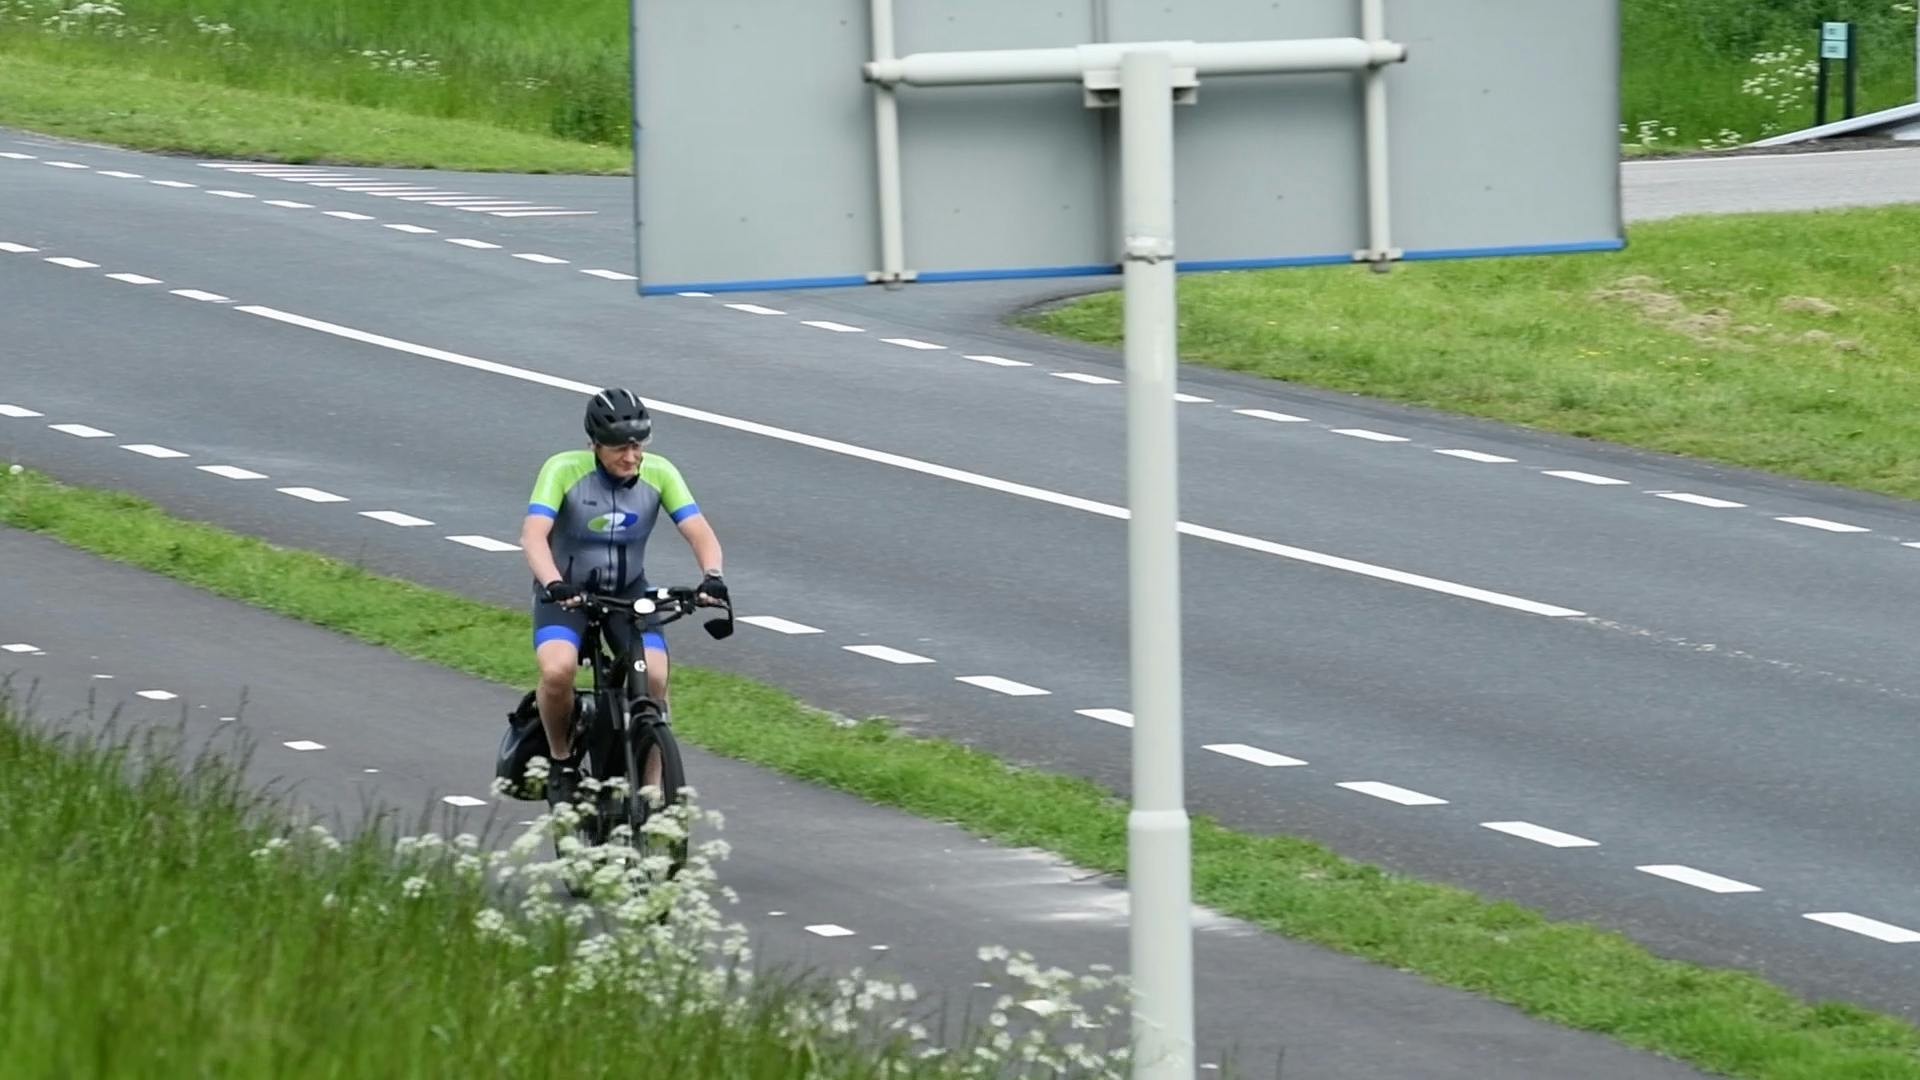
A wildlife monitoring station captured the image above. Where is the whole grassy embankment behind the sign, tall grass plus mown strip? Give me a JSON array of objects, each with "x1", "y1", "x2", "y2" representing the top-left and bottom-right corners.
[{"x1": 0, "y1": 0, "x2": 1914, "y2": 171}]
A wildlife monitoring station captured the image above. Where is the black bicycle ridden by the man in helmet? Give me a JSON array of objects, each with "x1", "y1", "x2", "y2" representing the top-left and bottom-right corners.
[{"x1": 553, "y1": 586, "x2": 733, "y2": 880}]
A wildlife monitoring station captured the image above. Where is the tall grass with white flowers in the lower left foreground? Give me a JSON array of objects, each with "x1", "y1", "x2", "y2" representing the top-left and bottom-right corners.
[{"x1": 0, "y1": 701, "x2": 1075, "y2": 1080}]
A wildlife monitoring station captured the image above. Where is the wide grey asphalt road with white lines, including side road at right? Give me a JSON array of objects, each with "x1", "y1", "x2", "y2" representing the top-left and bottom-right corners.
[{"x1": 0, "y1": 127, "x2": 1920, "y2": 1017}]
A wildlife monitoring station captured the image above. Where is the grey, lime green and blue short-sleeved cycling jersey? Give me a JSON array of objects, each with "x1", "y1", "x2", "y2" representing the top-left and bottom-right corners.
[{"x1": 526, "y1": 450, "x2": 701, "y2": 592}]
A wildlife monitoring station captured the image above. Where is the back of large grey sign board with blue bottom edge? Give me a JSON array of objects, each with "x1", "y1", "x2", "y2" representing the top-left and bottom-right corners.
[{"x1": 634, "y1": 0, "x2": 1622, "y2": 292}]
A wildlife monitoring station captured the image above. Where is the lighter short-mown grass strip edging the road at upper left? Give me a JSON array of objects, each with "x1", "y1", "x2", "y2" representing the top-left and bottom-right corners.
[{"x1": 0, "y1": 52, "x2": 632, "y2": 173}]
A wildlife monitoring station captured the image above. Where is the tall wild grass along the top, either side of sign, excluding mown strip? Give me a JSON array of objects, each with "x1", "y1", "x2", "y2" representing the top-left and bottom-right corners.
[{"x1": 0, "y1": 0, "x2": 1914, "y2": 146}]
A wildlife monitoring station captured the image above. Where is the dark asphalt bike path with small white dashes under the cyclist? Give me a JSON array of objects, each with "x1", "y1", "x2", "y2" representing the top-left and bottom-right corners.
[{"x1": 0, "y1": 528, "x2": 1699, "y2": 1080}]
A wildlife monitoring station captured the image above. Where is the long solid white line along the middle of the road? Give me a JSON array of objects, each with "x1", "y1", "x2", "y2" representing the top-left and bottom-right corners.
[{"x1": 236, "y1": 304, "x2": 1584, "y2": 619}]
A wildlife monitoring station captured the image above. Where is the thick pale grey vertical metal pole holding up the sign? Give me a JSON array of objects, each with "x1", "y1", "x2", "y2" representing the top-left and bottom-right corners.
[{"x1": 1119, "y1": 52, "x2": 1194, "y2": 1080}]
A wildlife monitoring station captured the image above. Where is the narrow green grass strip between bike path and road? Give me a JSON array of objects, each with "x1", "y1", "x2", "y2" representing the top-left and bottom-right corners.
[{"x1": 0, "y1": 471, "x2": 1920, "y2": 1080}]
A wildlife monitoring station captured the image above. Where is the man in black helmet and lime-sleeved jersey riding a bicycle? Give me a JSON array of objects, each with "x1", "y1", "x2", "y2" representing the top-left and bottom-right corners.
[{"x1": 520, "y1": 386, "x2": 728, "y2": 803}]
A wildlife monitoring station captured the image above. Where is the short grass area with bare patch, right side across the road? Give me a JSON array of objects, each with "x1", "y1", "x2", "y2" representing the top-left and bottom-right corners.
[{"x1": 1020, "y1": 206, "x2": 1920, "y2": 498}]
